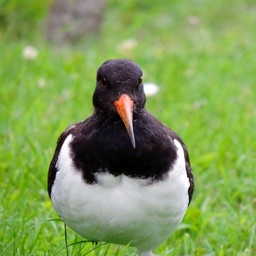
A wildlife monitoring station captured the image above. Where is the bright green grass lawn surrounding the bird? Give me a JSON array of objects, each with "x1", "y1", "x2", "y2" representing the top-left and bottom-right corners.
[{"x1": 0, "y1": 0, "x2": 256, "y2": 256}]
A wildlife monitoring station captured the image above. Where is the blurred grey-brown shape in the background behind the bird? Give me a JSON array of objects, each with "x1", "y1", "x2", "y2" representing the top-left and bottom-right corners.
[{"x1": 46, "y1": 0, "x2": 106, "y2": 44}]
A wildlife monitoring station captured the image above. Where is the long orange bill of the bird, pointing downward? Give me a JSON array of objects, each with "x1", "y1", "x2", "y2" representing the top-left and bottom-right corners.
[{"x1": 114, "y1": 94, "x2": 136, "y2": 148}]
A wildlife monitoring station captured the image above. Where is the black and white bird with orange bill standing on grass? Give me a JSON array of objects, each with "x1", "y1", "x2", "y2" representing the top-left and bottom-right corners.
[{"x1": 48, "y1": 59, "x2": 194, "y2": 256}]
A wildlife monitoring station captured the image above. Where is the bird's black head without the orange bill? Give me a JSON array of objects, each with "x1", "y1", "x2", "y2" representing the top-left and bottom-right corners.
[{"x1": 93, "y1": 59, "x2": 146, "y2": 112}]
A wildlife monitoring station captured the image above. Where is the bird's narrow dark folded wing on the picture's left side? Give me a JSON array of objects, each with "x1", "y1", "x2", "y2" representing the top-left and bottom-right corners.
[{"x1": 48, "y1": 122, "x2": 82, "y2": 197}]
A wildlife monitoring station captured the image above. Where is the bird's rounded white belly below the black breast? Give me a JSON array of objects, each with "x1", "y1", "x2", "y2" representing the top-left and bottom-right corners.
[{"x1": 51, "y1": 135, "x2": 189, "y2": 251}]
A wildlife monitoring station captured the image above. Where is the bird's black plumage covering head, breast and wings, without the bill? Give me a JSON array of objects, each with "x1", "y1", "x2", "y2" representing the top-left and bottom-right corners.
[{"x1": 48, "y1": 59, "x2": 194, "y2": 200}]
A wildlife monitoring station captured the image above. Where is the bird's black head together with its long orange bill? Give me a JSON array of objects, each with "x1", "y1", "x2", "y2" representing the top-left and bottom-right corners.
[{"x1": 93, "y1": 59, "x2": 146, "y2": 148}]
